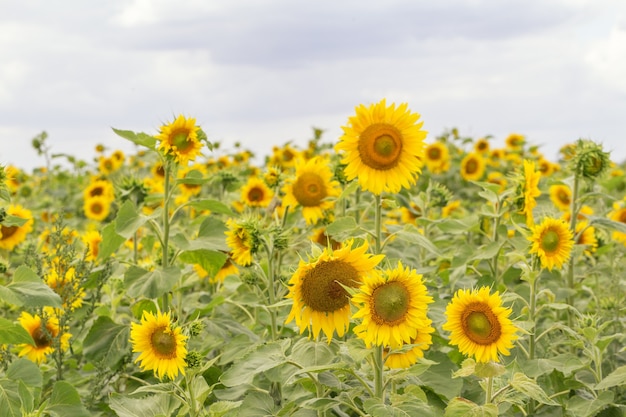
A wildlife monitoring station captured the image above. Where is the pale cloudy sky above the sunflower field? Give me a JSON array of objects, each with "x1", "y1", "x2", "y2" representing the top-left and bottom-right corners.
[{"x1": 0, "y1": 0, "x2": 626, "y2": 170}]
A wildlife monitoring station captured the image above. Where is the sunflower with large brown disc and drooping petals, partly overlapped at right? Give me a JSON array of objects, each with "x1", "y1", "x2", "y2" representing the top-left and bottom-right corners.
[{"x1": 285, "y1": 240, "x2": 384, "y2": 343}]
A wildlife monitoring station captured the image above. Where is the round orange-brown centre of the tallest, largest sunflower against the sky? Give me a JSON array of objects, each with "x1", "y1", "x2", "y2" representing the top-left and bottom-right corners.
[{"x1": 358, "y1": 123, "x2": 402, "y2": 171}]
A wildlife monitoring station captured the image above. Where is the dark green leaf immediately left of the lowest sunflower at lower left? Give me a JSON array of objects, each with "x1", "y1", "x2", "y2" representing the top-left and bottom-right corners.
[{"x1": 83, "y1": 316, "x2": 130, "y2": 369}]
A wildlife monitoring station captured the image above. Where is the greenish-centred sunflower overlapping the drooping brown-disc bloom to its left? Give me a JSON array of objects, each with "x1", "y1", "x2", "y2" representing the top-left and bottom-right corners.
[{"x1": 352, "y1": 262, "x2": 434, "y2": 350}]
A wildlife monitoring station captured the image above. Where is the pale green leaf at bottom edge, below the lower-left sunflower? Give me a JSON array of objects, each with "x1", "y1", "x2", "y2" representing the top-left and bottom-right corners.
[{"x1": 109, "y1": 393, "x2": 180, "y2": 417}]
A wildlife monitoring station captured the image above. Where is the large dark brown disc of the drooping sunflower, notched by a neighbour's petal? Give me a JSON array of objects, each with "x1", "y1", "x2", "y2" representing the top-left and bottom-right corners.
[{"x1": 302, "y1": 260, "x2": 360, "y2": 313}]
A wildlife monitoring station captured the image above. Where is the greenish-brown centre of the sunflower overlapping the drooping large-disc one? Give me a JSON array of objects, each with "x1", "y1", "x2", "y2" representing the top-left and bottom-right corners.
[{"x1": 372, "y1": 281, "x2": 410, "y2": 325}]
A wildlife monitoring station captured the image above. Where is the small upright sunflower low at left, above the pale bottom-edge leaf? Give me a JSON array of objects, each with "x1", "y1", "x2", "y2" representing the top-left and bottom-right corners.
[{"x1": 130, "y1": 310, "x2": 187, "y2": 379}]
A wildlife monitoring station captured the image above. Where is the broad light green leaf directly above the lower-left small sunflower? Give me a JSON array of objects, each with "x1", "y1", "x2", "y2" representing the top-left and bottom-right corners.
[{"x1": 124, "y1": 266, "x2": 180, "y2": 298}]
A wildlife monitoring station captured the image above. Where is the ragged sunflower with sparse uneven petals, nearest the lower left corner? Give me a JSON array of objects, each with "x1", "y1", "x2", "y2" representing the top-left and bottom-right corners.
[{"x1": 18, "y1": 311, "x2": 72, "y2": 363}]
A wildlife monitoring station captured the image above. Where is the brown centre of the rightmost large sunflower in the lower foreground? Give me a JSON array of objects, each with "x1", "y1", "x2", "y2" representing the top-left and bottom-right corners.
[{"x1": 461, "y1": 303, "x2": 502, "y2": 345}]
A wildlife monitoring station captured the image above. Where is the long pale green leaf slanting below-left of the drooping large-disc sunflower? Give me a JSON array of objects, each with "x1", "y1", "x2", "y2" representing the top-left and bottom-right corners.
[{"x1": 220, "y1": 342, "x2": 287, "y2": 387}]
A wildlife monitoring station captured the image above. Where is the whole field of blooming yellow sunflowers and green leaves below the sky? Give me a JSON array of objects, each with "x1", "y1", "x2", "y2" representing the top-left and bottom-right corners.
[{"x1": 0, "y1": 100, "x2": 626, "y2": 417}]
